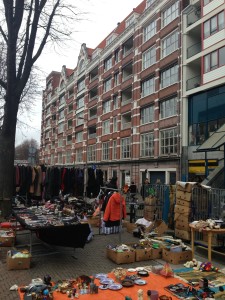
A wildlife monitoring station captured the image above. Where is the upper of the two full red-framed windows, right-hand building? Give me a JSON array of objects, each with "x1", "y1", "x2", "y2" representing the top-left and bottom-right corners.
[{"x1": 204, "y1": 11, "x2": 225, "y2": 39}]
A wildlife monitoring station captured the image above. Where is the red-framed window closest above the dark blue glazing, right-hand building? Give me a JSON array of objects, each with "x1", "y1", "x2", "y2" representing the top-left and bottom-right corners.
[{"x1": 204, "y1": 47, "x2": 225, "y2": 73}]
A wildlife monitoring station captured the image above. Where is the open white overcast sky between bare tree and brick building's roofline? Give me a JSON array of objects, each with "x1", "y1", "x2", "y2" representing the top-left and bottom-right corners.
[{"x1": 16, "y1": 0, "x2": 142, "y2": 145}]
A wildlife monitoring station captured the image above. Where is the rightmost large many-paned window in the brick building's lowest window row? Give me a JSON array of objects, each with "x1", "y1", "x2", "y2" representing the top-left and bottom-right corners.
[{"x1": 160, "y1": 128, "x2": 178, "y2": 155}]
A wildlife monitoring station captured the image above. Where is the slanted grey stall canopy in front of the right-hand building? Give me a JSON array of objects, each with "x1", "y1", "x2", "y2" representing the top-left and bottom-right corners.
[{"x1": 195, "y1": 124, "x2": 225, "y2": 186}]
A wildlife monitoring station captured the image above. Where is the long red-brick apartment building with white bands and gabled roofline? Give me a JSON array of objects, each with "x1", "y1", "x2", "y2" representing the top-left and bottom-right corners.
[{"x1": 40, "y1": 0, "x2": 189, "y2": 187}]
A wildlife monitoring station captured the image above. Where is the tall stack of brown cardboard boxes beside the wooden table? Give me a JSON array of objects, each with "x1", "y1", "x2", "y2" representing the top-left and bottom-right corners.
[{"x1": 174, "y1": 181, "x2": 195, "y2": 241}]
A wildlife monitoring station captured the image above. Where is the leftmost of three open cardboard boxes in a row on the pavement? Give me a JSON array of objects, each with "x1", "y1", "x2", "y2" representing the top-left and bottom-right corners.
[{"x1": 106, "y1": 249, "x2": 135, "y2": 265}]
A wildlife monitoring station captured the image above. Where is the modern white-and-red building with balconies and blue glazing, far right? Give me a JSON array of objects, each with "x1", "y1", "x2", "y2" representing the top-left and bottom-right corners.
[{"x1": 181, "y1": 0, "x2": 225, "y2": 180}]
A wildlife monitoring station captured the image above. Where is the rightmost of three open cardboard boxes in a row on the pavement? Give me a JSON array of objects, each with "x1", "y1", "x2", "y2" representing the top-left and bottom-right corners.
[{"x1": 162, "y1": 248, "x2": 192, "y2": 265}]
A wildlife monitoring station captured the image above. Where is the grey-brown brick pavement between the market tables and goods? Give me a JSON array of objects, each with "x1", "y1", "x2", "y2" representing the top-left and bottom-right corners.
[{"x1": 0, "y1": 228, "x2": 225, "y2": 300}]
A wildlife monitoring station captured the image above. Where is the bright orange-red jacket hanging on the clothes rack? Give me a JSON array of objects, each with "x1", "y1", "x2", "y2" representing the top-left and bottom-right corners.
[{"x1": 103, "y1": 193, "x2": 127, "y2": 222}]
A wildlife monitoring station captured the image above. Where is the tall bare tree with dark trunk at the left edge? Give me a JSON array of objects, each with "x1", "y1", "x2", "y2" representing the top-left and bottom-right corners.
[{"x1": 0, "y1": 0, "x2": 83, "y2": 216}]
